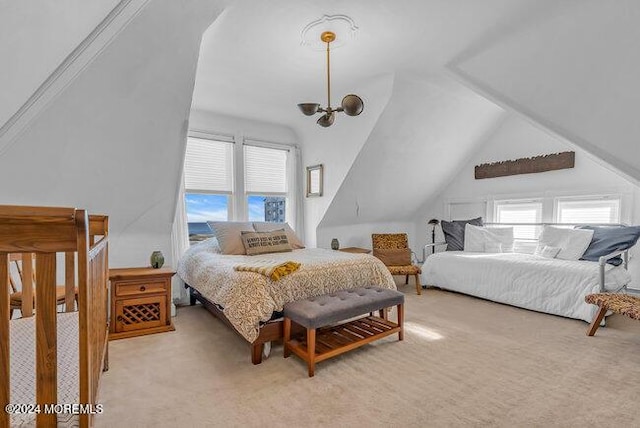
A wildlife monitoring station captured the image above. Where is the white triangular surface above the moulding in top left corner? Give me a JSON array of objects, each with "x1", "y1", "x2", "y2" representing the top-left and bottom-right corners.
[{"x1": 0, "y1": 0, "x2": 118, "y2": 126}]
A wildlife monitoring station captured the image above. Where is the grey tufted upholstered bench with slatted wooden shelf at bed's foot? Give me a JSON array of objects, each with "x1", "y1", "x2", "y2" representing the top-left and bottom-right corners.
[{"x1": 284, "y1": 287, "x2": 404, "y2": 377}]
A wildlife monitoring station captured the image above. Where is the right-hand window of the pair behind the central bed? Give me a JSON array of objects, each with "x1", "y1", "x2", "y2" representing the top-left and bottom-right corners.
[{"x1": 244, "y1": 145, "x2": 289, "y2": 222}]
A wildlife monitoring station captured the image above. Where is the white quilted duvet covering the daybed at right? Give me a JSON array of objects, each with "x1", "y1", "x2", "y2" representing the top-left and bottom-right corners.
[{"x1": 422, "y1": 251, "x2": 631, "y2": 322}]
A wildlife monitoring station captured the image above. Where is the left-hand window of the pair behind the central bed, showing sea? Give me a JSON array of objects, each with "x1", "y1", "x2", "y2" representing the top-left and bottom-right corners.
[{"x1": 184, "y1": 137, "x2": 233, "y2": 242}]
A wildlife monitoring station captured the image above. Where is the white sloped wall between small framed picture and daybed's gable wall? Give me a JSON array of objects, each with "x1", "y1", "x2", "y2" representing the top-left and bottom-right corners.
[{"x1": 318, "y1": 75, "x2": 502, "y2": 251}]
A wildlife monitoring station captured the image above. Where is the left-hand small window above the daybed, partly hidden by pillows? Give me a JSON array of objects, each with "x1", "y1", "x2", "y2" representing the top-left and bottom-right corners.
[{"x1": 493, "y1": 200, "x2": 542, "y2": 241}]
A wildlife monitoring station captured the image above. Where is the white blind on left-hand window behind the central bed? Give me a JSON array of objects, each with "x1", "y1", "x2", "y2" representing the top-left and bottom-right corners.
[{"x1": 184, "y1": 137, "x2": 233, "y2": 193}]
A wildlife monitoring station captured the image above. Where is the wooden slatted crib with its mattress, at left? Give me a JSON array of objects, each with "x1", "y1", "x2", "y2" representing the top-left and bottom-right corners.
[{"x1": 0, "y1": 206, "x2": 108, "y2": 428}]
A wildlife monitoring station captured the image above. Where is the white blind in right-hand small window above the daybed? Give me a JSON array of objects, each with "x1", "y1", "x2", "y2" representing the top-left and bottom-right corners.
[{"x1": 557, "y1": 198, "x2": 620, "y2": 224}]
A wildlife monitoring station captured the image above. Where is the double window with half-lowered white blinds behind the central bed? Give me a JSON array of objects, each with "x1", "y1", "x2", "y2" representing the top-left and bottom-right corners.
[{"x1": 184, "y1": 132, "x2": 295, "y2": 243}]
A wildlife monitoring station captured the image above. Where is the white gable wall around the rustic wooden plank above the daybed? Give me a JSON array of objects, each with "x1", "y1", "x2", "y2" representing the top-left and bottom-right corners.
[{"x1": 415, "y1": 115, "x2": 640, "y2": 288}]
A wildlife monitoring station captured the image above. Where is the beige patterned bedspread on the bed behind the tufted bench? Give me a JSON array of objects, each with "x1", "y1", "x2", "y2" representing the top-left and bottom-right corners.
[{"x1": 178, "y1": 241, "x2": 396, "y2": 342}]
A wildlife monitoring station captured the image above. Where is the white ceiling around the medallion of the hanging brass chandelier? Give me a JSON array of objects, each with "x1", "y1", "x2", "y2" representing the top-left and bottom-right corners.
[{"x1": 192, "y1": 0, "x2": 557, "y2": 129}]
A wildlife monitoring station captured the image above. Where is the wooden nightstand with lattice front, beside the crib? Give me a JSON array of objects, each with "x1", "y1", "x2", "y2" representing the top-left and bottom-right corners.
[{"x1": 109, "y1": 268, "x2": 175, "y2": 340}]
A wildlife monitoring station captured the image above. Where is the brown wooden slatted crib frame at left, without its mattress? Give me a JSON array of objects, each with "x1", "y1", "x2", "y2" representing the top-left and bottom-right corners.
[{"x1": 0, "y1": 206, "x2": 109, "y2": 428}]
